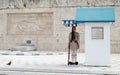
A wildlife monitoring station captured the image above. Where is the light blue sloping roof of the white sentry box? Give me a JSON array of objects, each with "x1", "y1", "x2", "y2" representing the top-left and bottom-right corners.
[{"x1": 75, "y1": 8, "x2": 115, "y2": 22}]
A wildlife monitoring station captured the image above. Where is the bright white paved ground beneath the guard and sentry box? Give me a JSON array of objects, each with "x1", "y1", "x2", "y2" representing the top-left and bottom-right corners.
[{"x1": 0, "y1": 52, "x2": 120, "y2": 75}]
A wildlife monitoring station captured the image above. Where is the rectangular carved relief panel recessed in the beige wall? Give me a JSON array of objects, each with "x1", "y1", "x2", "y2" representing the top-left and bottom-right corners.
[{"x1": 7, "y1": 12, "x2": 53, "y2": 35}]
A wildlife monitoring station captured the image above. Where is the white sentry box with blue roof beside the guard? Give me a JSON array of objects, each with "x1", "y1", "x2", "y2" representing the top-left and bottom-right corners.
[{"x1": 63, "y1": 8, "x2": 115, "y2": 66}]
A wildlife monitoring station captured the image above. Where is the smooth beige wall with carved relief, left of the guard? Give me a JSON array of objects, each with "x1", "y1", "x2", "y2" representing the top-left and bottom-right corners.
[{"x1": 0, "y1": 8, "x2": 78, "y2": 51}]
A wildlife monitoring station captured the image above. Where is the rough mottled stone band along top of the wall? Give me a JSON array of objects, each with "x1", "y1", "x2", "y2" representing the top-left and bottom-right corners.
[{"x1": 0, "y1": 0, "x2": 120, "y2": 9}]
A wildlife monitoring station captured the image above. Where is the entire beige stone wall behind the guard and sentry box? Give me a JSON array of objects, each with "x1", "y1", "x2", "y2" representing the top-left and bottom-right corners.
[{"x1": 0, "y1": 0, "x2": 120, "y2": 53}]
